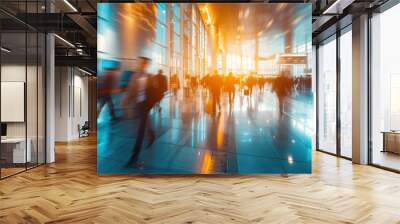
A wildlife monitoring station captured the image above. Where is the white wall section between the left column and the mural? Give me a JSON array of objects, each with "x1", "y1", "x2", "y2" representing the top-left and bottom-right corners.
[{"x1": 55, "y1": 67, "x2": 89, "y2": 141}]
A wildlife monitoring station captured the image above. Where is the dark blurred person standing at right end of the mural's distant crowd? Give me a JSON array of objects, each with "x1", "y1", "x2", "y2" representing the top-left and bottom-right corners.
[{"x1": 272, "y1": 71, "x2": 293, "y2": 117}]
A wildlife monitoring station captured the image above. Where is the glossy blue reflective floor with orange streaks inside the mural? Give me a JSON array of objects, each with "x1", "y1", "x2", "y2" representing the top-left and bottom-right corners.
[{"x1": 97, "y1": 87, "x2": 313, "y2": 174}]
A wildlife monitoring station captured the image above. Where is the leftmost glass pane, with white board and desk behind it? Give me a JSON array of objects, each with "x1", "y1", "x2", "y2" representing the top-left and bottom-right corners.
[{"x1": 0, "y1": 31, "x2": 27, "y2": 178}]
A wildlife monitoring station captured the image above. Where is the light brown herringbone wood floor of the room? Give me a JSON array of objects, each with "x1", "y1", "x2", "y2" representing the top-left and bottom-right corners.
[{"x1": 0, "y1": 138, "x2": 400, "y2": 224}]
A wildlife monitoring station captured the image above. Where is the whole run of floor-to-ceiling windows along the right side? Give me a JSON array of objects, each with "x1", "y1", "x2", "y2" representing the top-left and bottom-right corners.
[{"x1": 316, "y1": 1, "x2": 400, "y2": 172}]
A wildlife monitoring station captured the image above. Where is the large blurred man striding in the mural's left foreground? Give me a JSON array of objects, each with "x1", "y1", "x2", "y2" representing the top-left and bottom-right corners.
[{"x1": 122, "y1": 57, "x2": 157, "y2": 165}]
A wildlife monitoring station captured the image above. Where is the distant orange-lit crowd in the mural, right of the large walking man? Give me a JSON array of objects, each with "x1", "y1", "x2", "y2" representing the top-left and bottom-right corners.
[{"x1": 180, "y1": 70, "x2": 311, "y2": 113}]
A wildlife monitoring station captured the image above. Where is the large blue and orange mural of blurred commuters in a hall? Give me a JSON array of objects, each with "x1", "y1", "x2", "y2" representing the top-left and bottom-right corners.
[{"x1": 97, "y1": 3, "x2": 314, "y2": 174}]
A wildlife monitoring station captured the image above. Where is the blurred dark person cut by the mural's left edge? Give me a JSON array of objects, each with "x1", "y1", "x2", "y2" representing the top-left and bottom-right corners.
[{"x1": 97, "y1": 66, "x2": 119, "y2": 120}]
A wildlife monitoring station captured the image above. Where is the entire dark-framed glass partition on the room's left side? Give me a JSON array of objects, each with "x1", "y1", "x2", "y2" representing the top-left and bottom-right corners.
[{"x1": 0, "y1": 1, "x2": 46, "y2": 178}]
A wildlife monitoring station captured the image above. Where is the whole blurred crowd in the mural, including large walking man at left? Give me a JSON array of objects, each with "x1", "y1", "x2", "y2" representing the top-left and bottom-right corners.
[{"x1": 97, "y1": 57, "x2": 311, "y2": 166}]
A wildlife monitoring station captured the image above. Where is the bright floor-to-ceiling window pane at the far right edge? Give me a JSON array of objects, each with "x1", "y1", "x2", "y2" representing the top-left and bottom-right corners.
[{"x1": 370, "y1": 4, "x2": 400, "y2": 171}]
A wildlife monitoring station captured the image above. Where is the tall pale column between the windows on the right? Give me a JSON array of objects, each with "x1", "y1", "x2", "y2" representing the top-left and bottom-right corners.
[{"x1": 352, "y1": 15, "x2": 368, "y2": 164}]
